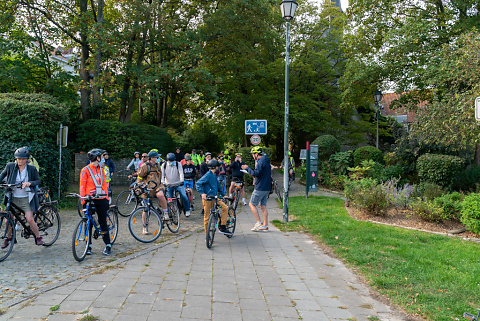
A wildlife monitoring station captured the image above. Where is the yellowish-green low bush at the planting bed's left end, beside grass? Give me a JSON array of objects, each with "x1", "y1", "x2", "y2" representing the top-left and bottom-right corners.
[{"x1": 345, "y1": 178, "x2": 390, "y2": 216}]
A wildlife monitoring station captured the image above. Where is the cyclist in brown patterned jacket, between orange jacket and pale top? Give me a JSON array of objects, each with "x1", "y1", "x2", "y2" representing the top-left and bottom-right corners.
[{"x1": 137, "y1": 150, "x2": 169, "y2": 230}]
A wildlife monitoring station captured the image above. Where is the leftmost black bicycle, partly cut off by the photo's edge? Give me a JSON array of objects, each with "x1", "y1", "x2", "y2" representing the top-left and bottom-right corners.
[{"x1": 0, "y1": 184, "x2": 61, "y2": 262}]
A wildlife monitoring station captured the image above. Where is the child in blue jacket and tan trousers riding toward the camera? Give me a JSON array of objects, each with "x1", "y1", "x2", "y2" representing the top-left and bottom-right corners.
[{"x1": 196, "y1": 159, "x2": 228, "y2": 233}]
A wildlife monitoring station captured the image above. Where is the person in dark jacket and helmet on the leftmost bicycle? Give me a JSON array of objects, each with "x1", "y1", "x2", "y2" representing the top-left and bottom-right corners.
[{"x1": 0, "y1": 147, "x2": 43, "y2": 249}]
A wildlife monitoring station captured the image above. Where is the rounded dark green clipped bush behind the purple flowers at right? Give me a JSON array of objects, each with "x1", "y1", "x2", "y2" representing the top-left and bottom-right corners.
[{"x1": 417, "y1": 154, "x2": 464, "y2": 188}]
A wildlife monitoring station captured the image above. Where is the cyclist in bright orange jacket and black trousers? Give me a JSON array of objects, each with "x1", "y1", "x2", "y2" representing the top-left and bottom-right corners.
[{"x1": 80, "y1": 148, "x2": 112, "y2": 256}]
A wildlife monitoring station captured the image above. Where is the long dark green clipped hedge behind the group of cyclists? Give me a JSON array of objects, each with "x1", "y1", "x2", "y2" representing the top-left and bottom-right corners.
[{"x1": 76, "y1": 119, "x2": 175, "y2": 158}]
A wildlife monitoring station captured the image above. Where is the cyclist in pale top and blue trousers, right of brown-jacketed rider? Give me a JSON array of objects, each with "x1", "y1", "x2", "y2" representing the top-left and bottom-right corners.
[{"x1": 162, "y1": 153, "x2": 190, "y2": 217}]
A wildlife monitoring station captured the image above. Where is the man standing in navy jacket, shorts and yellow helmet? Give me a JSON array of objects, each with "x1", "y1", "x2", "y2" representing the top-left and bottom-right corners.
[{"x1": 242, "y1": 146, "x2": 272, "y2": 232}]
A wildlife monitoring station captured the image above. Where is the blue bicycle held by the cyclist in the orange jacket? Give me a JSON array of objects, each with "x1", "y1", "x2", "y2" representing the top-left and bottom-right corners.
[{"x1": 67, "y1": 193, "x2": 118, "y2": 262}]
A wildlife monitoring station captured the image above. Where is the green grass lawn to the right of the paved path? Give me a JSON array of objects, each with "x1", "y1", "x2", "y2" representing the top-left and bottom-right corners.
[{"x1": 274, "y1": 197, "x2": 480, "y2": 320}]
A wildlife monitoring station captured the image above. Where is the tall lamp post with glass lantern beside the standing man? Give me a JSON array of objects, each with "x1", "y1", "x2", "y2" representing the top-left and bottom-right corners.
[{"x1": 280, "y1": 0, "x2": 298, "y2": 222}]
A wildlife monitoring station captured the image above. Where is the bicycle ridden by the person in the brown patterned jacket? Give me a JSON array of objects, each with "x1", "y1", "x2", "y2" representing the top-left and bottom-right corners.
[{"x1": 128, "y1": 181, "x2": 163, "y2": 243}]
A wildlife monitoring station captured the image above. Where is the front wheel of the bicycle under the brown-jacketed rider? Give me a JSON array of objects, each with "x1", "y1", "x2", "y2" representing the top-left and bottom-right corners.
[{"x1": 128, "y1": 206, "x2": 162, "y2": 243}]
